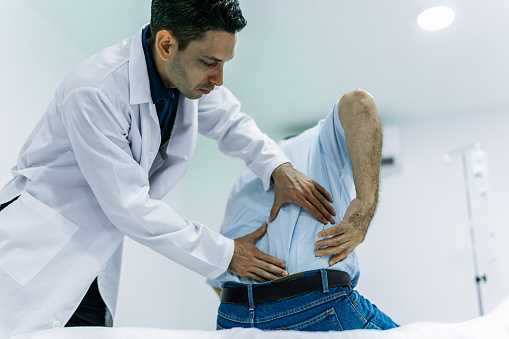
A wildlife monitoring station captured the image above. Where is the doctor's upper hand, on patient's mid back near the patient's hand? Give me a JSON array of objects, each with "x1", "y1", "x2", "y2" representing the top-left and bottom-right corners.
[{"x1": 269, "y1": 162, "x2": 336, "y2": 225}]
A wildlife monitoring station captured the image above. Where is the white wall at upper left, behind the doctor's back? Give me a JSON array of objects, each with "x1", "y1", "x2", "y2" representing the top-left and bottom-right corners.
[{"x1": 0, "y1": 0, "x2": 85, "y2": 186}]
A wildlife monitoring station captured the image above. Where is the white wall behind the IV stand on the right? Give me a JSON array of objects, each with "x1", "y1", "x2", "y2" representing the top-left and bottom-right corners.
[{"x1": 359, "y1": 110, "x2": 509, "y2": 323}]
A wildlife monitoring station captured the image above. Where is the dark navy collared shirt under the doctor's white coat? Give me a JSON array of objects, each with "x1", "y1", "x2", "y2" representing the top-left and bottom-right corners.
[{"x1": 141, "y1": 25, "x2": 180, "y2": 145}]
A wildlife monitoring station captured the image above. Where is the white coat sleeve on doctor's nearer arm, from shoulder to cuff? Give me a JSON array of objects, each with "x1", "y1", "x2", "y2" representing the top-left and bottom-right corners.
[{"x1": 58, "y1": 88, "x2": 234, "y2": 278}]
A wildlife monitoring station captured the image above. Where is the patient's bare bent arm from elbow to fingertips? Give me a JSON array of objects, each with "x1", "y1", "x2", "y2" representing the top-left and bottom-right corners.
[{"x1": 315, "y1": 90, "x2": 382, "y2": 266}]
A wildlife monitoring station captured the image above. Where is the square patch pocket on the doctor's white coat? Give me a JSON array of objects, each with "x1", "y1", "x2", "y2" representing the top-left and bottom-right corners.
[{"x1": 0, "y1": 192, "x2": 78, "y2": 286}]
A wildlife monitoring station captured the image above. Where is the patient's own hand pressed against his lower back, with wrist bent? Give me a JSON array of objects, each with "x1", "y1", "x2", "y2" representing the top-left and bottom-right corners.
[{"x1": 315, "y1": 198, "x2": 377, "y2": 266}]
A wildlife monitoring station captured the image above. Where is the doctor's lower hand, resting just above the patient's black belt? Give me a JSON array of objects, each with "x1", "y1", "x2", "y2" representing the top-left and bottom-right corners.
[{"x1": 228, "y1": 222, "x2": 288, "y2": 282}]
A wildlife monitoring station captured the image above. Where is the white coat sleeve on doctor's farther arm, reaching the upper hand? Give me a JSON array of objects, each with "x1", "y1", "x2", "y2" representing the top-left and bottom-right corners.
[{"x1": 198, "y1": 86, "x2": 290, "y2": 190}]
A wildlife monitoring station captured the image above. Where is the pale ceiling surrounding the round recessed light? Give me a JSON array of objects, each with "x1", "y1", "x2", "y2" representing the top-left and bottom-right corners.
[{"x1": 27, "y1": 0, "x2": 509, "y2": 137}]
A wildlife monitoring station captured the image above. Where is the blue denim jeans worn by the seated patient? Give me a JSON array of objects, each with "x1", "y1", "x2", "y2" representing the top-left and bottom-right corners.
[{"x1": 217, "y1": 271, "x2": 398, "y2": 331}]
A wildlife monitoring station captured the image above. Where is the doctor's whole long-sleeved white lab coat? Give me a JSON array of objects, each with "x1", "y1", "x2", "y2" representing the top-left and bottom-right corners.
[{"x1": 0, "y1": 25, "x2": 288, "y2": 338}]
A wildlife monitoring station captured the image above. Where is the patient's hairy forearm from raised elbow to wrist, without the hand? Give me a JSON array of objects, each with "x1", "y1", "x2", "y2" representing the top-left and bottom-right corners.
[{"x1": 338, "y1": 90, "x2": 383, "y2": 214}]
